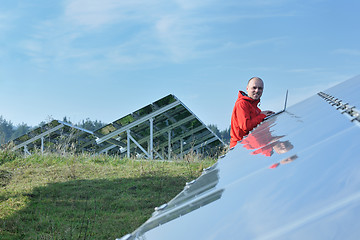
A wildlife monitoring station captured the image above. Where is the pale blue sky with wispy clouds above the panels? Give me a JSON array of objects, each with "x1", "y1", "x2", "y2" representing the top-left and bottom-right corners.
[{"x1": 0, "y1": 0, "x2": 360, "y2": 130}]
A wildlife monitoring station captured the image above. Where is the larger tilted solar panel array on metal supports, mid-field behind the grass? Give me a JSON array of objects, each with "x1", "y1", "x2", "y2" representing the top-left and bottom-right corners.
[{"x1": 94, "y1": 94, "x2": 224, "y2": 159}]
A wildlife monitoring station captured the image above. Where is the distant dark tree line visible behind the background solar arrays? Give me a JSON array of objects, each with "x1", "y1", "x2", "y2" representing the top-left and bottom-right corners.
[{"x1": 0, "y1": 116, "x2": 230, "y2": 145}]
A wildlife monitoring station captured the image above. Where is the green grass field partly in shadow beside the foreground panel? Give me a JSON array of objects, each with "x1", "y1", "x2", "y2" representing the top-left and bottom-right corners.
[{"x1": 0, "y1": 151, "x2": 215, "y2": 240}]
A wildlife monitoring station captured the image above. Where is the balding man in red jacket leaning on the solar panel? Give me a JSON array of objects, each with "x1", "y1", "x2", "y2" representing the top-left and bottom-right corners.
[{"x1": 230, "y1": 77, "x2": 274, "y2": 148}]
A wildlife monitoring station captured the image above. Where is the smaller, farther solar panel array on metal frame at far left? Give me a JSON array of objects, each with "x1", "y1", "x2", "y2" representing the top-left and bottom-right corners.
[{"x1": 13, "y1": 120, "x2": 98, "y2": 154}]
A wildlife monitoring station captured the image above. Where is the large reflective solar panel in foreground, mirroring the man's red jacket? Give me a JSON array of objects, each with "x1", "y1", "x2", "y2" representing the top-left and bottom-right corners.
[{"x1": 116, "y1": 76, "x2": 360, "y2": 240}]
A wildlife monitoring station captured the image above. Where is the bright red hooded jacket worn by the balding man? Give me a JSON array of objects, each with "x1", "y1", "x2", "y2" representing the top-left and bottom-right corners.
[{"x1": 230, "y1": 91, "x2": 266, "y2": 148}]
